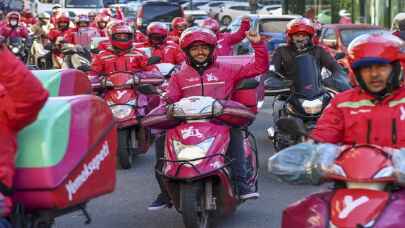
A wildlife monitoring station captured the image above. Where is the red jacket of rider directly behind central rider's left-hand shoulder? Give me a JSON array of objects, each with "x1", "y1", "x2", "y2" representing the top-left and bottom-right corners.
[{"x1": 137, "y1": 40, "x2": 184, "y2": 65}]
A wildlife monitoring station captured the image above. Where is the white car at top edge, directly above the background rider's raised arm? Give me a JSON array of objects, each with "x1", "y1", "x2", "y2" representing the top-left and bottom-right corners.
[{"x1": 218, "y1": 2, "x2": 250, "y2": 25}]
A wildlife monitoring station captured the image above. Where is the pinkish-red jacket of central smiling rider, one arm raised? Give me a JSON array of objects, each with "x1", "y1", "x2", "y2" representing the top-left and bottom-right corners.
[{"x1": 167, "y1": 42, "x2": 269, "y2": 103}]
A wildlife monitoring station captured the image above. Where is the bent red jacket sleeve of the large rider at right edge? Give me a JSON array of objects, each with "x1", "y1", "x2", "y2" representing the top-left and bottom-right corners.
[{"x1": 311, "y1": 99, "x2": 344, "y2": 144}]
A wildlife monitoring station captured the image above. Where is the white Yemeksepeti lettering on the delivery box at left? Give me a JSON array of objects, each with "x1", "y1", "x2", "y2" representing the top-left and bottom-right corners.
[{"x1": 65, "y1": 142, "x2": 110, "y2": 201}]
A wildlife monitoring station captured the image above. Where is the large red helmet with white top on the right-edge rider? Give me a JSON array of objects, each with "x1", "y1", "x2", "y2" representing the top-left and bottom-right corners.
[{"x1": 348, "y1": 32, "x2": 404, "y2": 90}]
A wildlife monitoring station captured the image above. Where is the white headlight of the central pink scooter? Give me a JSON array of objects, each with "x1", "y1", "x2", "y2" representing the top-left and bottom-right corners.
[{"x1": 173, "y1": 137, "x2": 215, "y2": 166}]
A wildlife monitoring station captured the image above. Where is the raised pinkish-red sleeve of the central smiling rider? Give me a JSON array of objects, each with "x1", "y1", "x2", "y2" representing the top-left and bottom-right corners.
[{"x1": 235, "y1": 41, "x2": 269, "y2": 81}]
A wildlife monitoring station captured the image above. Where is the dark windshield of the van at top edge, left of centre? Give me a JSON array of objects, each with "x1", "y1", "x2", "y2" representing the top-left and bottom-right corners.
[{"x1": 143, "y1": 4, "x2": 183, "y2": 22}]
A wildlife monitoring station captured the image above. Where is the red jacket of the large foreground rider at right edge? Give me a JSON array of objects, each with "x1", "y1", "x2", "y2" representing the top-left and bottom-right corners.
[{"x1": 312, "y1": 87, "x2": 405, "y2": 148}]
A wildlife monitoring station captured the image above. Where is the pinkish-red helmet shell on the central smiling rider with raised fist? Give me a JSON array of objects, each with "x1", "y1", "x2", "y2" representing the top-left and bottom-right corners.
[{"x1": 179, "y1": 27, "x2": 217, "y2": 50}]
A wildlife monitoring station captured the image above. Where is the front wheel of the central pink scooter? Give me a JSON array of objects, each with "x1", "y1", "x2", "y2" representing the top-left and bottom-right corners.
[{"x1": 180, "y1": 183, "x2": 211, "y2": 228}]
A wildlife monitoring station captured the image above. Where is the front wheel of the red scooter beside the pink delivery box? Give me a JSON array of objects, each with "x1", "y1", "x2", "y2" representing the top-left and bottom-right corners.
[{"x1": 118, "y1": 129, "x2": 134, "y2": 169}]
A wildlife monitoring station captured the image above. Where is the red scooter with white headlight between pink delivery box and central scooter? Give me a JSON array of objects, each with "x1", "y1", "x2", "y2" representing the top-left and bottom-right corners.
[{"x1": 100, "y1": 72, "x2": 164, "y2": 169}]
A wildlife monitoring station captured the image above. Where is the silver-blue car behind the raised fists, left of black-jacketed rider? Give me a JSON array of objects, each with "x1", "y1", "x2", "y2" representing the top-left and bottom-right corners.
[{"x1": 227, "y1": 14, "x2": 301, "y2": 54}]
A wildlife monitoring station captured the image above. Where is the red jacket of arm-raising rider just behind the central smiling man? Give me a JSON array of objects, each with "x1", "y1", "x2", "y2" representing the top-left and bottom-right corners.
[{"x1": 216, "y1": 20, "x2": 250, "y2": 56}]
